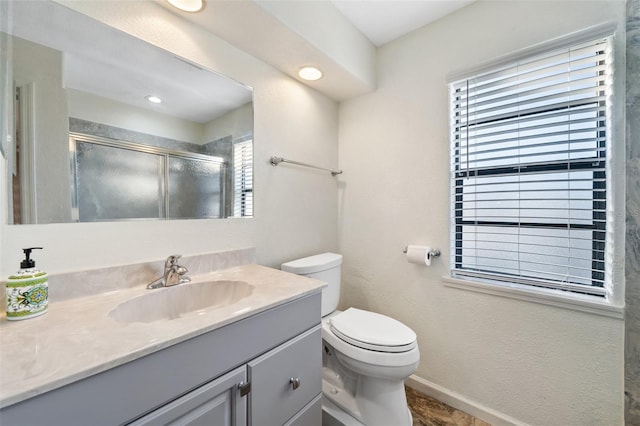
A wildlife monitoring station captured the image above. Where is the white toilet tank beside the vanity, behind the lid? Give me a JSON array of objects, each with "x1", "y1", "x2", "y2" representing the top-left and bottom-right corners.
[{"x1": 281, "y1": 253, "x2": 342, "y2": 316}]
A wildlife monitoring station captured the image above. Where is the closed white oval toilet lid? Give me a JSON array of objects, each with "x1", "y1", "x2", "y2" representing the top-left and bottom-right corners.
[{"x1": 330, "y1": 308, "x2": 416, "y2": 352}]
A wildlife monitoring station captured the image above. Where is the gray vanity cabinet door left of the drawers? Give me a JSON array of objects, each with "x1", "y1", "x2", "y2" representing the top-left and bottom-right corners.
[{"x1": 130, "y1": 366, "x2": 247, "y2": 426}]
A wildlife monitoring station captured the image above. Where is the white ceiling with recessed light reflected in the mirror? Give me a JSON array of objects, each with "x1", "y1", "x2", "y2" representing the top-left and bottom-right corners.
[{"x1": 11, "y1": 0, "x2": 252, "y2": 124}]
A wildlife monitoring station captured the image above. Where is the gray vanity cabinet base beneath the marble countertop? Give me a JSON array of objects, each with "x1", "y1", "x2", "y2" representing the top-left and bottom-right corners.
[{"x1": 0, "y1": 291, "x2": 322, "y2": 426}]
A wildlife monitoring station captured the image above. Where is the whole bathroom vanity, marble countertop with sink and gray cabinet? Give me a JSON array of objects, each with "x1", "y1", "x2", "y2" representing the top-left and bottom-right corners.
[{"x1": 0, "y1": 251, "x2": 324, "y2": 426}]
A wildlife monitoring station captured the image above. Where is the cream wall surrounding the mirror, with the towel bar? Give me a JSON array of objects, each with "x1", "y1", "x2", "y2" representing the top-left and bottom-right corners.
[{"x1": 0, "y1": 1, "x2": 338, "y2": 277}]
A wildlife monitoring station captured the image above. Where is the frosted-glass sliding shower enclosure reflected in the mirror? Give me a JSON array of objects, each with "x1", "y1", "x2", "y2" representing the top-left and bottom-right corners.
[{"x1": 69, "y1": 133, "x2": 228, "y2": 222}]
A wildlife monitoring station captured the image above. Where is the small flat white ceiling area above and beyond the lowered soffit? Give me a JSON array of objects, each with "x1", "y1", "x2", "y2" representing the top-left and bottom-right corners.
[{"x1": 332, "y1": 0, "x2": 475, "y2": 46}]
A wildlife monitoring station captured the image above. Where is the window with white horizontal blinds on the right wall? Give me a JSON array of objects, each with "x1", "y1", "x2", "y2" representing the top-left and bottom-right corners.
[{"x1": 449, "y1": 37, "x2": 612, "y2": 296}]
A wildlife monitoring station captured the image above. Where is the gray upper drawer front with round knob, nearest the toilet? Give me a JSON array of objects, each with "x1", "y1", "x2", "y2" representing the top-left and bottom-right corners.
[{"x1": 249, "y1": 325, "x2": 322, "y2": 426}]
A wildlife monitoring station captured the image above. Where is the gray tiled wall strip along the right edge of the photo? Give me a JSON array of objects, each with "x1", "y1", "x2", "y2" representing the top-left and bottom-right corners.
[{"x1": 624, "y1": 0, "x2": 640, "y2": 425}]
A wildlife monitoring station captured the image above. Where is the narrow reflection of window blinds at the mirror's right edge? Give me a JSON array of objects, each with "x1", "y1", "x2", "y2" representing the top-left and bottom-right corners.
[{"x1": 233, "y1": 139, "x2": 253, "y2": 217}]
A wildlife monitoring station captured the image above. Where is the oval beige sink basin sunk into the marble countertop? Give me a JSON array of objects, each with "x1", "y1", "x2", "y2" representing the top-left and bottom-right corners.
[{"x1": 109, "y1": 281, "x2": 253, "y2": 323}]
